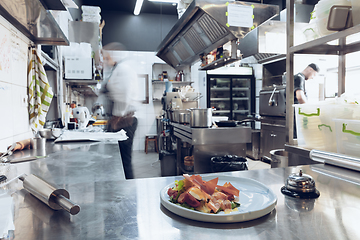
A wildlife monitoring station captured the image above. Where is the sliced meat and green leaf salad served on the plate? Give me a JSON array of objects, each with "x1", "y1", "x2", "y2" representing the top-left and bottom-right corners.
[{"x1": 167, "y1": 174, "x2": 240, "y2": 213}]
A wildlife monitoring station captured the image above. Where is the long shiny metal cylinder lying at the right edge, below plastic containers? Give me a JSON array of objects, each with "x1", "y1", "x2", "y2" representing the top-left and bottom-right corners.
[{"x1": 310, "y1": 150, "x2": 360, "y2": 171}]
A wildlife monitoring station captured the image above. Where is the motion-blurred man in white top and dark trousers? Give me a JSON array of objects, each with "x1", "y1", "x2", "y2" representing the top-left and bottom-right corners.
[{"x1": 101, "y1": 42, "x2": 140, "y2": 179}]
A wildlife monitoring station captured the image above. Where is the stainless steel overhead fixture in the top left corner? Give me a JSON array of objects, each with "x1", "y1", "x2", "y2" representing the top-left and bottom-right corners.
[{"x1": 0, "y1": 0, "x2": 69, "y2": 45}]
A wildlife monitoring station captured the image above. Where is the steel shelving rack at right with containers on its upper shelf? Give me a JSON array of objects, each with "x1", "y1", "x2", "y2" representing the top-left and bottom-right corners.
[{"x1": 286, "y1": 0, "x2": 360, "y2": 145}]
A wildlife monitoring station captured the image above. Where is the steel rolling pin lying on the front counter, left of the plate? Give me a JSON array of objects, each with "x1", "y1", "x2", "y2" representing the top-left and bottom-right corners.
[{"x1": 19, "y1": 174, "x2": 80, "y2": 215}]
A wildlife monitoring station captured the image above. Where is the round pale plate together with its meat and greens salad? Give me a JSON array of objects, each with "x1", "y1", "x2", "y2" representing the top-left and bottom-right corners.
[{"x1": 160, "y1": 174, "x2": 277, "y2": 223}]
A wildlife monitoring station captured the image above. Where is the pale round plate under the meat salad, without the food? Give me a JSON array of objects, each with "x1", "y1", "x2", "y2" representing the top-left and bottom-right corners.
[{"x1": 160, "y1": 176, "x2": 277, "y2": 223}]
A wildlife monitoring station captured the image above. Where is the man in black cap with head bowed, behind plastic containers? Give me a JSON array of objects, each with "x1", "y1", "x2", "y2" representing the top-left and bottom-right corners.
[{"x1": 294, "y1": 63, "x2": 320, "y2": 104}]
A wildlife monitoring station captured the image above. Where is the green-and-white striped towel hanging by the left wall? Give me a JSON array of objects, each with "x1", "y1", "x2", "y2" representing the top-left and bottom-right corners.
[{"x1": 28, "y1": 48, "x2": 54, "y2": 132}]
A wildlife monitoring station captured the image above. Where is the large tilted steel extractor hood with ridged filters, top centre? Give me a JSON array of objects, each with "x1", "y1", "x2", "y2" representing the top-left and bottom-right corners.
[{"x1": 157, "y1": 0, "x2": 279, "y2": 69}]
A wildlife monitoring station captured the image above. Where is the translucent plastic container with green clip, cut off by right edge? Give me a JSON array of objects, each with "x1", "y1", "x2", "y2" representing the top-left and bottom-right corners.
[{"x1": 333, "y1": 119, "x2": 360, "y2": 157}]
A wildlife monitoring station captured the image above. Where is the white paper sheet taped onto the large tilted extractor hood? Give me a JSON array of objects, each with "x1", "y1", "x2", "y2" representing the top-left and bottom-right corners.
[{"x1": 227, "y1": 4, "x2": 254, "y2": 28}]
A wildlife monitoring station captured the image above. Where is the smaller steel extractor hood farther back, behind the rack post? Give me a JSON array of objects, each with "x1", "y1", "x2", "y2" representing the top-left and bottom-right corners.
[{"x1": 238, "y1": 4, "x2": 314, "y2": 63}]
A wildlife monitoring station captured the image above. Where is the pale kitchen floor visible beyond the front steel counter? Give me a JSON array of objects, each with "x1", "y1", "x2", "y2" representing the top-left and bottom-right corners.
[{"x1": 132, "y1": 151, "x2": 270, "y2": 178}]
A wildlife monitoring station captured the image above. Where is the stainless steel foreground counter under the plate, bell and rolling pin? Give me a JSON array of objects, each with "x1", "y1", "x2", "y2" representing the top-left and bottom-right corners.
[{"x1": 3, "y1": 143, "x2": 360, "y2": 240}]
